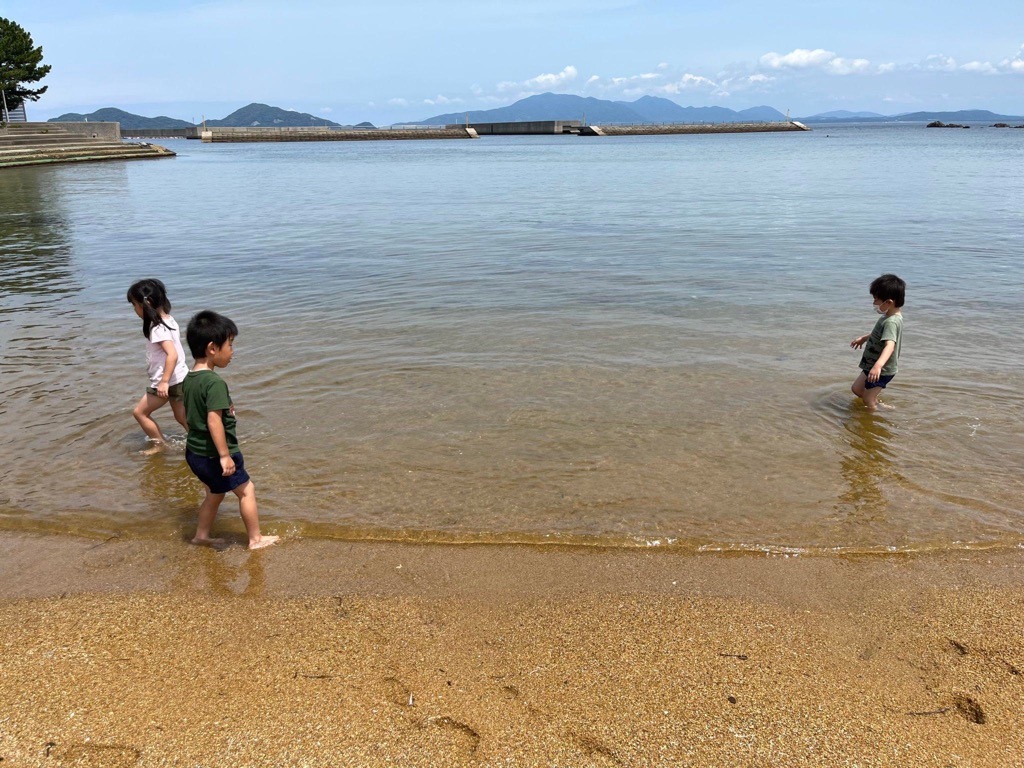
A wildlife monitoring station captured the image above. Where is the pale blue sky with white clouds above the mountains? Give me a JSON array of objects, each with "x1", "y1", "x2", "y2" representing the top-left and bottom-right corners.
[{"x1": 6, "y1": 0, "x2": 1024, "y2": 125}]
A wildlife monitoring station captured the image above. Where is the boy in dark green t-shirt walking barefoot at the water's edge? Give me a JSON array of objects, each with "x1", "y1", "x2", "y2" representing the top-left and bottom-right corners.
[{"x1": 181, "y1": 309, "x2": 280, "y2": 549}]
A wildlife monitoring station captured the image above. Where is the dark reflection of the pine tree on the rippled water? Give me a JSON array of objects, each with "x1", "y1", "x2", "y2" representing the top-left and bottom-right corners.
[{"x1": 0, "y1": 169, "x2": 80, "y2": 313}]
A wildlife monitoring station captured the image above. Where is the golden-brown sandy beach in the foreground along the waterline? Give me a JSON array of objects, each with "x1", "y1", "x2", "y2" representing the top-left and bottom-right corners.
[{"x1": 0, "y1": 535, "x2": 1024, "y2": 768}]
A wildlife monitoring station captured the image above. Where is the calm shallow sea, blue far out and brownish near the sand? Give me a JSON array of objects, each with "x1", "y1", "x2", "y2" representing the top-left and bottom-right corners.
[{"x1": 0, "y1": 125, "x2": 1024, "y2": 552}]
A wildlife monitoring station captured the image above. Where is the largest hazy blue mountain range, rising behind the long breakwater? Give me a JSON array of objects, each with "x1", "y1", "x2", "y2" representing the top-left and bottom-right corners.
[{"x1": 413, "y1": 93, "x2": 785, "y2": 125}]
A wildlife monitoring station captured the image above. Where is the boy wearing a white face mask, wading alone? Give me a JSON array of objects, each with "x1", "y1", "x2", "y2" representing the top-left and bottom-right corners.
[{"x1": 850, "y1": 274, "x2": 906, "y2": 411}]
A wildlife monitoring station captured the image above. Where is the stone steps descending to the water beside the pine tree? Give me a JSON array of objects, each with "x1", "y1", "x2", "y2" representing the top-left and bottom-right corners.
[{"x1": 0, "y1": 123, "x2": 174, "y2": 168}]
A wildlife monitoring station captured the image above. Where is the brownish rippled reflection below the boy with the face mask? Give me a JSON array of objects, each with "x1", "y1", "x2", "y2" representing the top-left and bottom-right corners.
[{"x1": 836, "y1": 406, "x2": 899, "y2": 524}]
